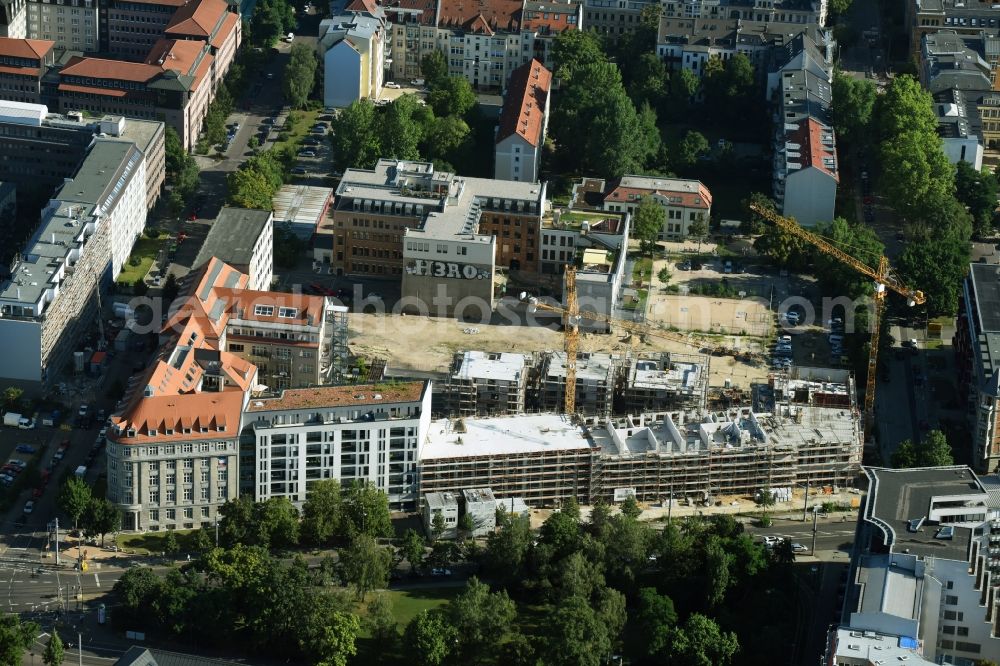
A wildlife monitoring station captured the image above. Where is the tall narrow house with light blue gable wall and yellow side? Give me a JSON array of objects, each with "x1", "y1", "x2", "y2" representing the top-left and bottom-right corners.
[{"x1": 316, "y1": 0, "x2": 391, "y2": 108}]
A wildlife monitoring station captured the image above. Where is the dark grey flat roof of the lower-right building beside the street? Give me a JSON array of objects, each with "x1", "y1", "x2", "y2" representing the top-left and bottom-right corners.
[{"x1": 865, "y1": 465, "x2": 988, "y2": 561}]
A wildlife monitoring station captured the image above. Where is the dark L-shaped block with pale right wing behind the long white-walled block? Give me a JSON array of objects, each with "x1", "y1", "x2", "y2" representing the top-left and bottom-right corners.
[{"x1": 0, "y1": 101, "x2": 165, "y2": 209}]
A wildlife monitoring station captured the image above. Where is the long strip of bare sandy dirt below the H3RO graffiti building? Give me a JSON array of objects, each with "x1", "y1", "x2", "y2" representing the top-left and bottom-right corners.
[{"x1": 348, "y1": 313, "x2": 767, "y2": 387}]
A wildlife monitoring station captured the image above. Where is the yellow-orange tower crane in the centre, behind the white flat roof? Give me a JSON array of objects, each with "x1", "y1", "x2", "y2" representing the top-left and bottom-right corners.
[{"x1": 529, "y1": 267, "x2": 762, "y2": 414}]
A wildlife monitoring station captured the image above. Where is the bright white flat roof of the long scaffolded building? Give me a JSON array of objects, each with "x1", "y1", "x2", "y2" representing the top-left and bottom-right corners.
[{"x1": 420, "y1": 414, "x2": 594, "y2": 461}]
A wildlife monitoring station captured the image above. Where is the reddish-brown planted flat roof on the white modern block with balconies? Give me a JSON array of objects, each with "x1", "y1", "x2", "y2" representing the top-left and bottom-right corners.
[{"x1": 246, "y1": 382, "x2": 427, "y2": 412}]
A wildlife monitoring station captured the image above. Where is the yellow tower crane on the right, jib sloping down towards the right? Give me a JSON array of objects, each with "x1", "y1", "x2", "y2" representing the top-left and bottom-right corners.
[{"x1": 750, "y1": 204, "x2": 926, "y2": 434}]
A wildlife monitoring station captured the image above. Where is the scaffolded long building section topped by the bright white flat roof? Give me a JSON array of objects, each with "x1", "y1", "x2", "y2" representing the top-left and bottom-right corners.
[{"x1": 420, "y1": 414, "x2": 594, "y2": 506}]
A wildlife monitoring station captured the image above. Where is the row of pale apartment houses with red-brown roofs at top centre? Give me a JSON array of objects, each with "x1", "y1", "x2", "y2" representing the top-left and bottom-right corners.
[{"x1": 384, "y1": 0, "x2": 583, "y2": 90}]
